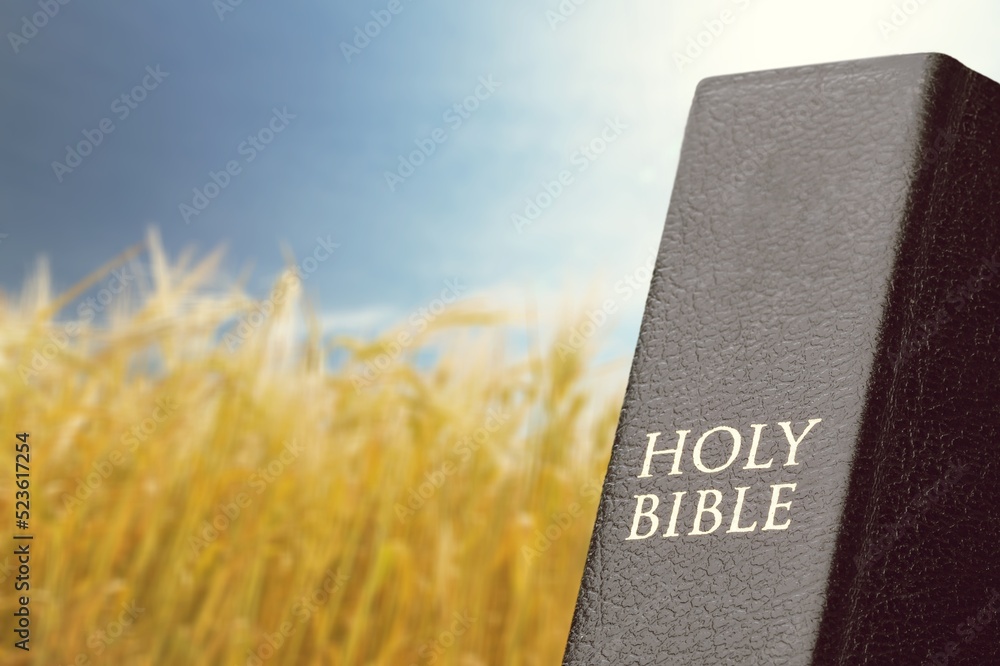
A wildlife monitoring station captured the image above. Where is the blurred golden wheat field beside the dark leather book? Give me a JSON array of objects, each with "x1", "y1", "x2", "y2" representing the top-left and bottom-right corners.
[{"x1": 0, "y1": 231, "x2": 625, "y2": 666}]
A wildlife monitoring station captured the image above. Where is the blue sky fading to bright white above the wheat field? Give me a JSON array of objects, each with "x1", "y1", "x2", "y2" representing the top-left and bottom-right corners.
[{"x1": 0, "y1": 0, "x2": 1000, "y2": 364}]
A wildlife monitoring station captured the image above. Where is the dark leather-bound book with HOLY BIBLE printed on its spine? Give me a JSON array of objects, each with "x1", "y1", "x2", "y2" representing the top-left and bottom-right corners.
[{"x1": 564, "y1": 54, "x2": 1000, "y2": 666}]
